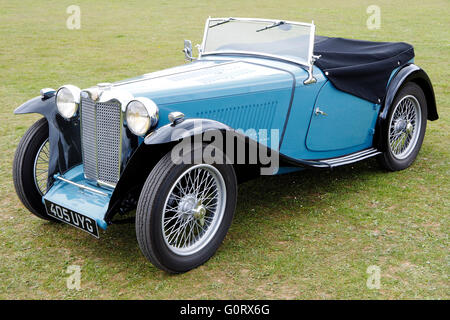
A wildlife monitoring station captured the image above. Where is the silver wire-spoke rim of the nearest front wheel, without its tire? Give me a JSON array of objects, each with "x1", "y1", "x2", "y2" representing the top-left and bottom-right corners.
[{"x1": 162, "y1": 164, "x2": 226, "y2": 255}]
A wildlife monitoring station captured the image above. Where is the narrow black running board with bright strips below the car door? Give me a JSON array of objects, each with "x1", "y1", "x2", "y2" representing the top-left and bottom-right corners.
[{"x1": 283, "y1": 148, "x2": 382, "y2": 169}]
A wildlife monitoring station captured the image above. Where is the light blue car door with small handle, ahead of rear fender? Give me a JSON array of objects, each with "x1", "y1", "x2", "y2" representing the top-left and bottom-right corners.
[{"x1": 306, "y1": 81, "x2": 379, "y2": 152}]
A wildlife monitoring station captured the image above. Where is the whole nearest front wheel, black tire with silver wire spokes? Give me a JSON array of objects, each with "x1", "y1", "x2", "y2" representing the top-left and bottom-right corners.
[{"x1": 136, "y1": 152, "x2": 237, "y2": 273}]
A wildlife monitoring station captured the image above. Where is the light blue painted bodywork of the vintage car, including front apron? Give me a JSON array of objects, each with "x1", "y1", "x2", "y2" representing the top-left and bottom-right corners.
[{"x1": 35, "y1": 56, "x2": 404, "y2": 229}]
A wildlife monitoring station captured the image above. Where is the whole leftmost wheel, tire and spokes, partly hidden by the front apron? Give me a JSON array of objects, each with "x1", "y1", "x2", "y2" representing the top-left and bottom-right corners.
[{"x1": 13, "y1": 118, "x2": 56, "y2": 221}]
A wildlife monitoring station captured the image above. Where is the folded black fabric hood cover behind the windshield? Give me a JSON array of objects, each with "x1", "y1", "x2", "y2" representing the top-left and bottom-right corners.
[{"x1": 314, "y1": 36, "x2": 414, "y2": 103}]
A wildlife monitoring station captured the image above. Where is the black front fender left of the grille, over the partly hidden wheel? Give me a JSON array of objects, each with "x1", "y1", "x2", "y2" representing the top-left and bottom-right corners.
[{"x1": 14, "y1": 95, "x2": 81, "y2": 187}]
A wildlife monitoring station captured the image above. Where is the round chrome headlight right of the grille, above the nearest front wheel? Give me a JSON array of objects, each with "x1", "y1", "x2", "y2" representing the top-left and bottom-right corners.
[{"x1": 125, "y1": 98, "x2": 159, "y2": 136}]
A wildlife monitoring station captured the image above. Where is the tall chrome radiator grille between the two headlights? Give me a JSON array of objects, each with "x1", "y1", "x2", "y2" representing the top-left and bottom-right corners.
[{"x1": 80, "y1": 98, "x2": 122, "y2": 185}]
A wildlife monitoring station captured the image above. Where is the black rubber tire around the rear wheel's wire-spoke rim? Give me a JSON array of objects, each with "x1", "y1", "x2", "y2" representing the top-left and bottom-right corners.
[{"x1": 378, "y1": 82, "x2": 427, "y2": 171}]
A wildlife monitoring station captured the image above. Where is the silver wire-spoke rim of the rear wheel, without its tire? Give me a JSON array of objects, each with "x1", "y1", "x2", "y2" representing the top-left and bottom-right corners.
[{"x1": 389, "y1": 95, "x2": 422, "y2": 160}]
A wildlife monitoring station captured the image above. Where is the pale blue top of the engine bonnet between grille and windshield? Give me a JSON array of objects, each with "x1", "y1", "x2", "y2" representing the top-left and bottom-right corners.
[{"x1": 114, "y1": 58, "x2": 292, "y2": 108}]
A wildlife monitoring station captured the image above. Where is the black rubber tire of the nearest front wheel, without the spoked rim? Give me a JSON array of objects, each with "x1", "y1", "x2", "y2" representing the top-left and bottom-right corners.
[{"x1": 136, "y1": 152, "x2": 237, "y2": 273}]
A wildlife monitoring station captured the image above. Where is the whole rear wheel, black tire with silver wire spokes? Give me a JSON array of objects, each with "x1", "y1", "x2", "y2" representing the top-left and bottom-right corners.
[{"x1": 379, "y1": 82, "x2": 427, "y2": 171}]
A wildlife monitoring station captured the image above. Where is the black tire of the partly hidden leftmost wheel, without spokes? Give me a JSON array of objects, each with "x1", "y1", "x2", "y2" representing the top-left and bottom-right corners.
[{"x1": 13, "y1": 118, "x2": 56, "y2": 221}]
